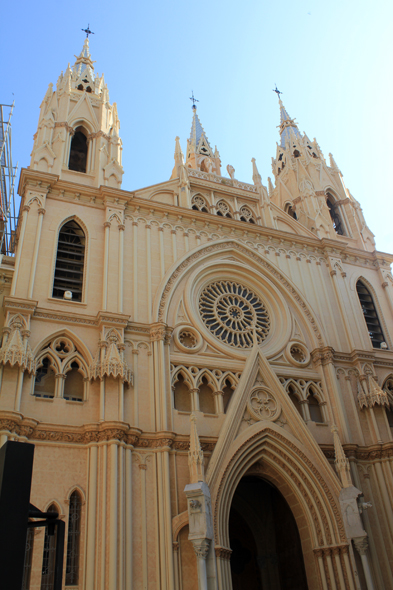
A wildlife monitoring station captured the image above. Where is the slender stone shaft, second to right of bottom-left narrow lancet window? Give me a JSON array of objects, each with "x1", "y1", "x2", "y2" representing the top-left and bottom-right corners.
[{"x1": 108, "y1": 442, "x2": 118, "y2": 589}]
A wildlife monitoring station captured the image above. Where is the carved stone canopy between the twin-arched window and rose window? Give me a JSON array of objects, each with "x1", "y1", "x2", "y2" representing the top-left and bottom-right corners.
[{"x1": 90, "y1": 328, "x2": 133, "y2": 385}]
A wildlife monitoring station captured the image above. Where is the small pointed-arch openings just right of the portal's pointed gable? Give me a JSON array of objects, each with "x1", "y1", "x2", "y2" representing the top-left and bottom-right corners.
[{"x1": 280, "y1": 377, "x2": 328, "y2": 423}]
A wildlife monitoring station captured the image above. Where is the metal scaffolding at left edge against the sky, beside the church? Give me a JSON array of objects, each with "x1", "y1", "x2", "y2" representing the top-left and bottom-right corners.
[{"x1": 0, "y1": 103, "x2": 18, "y2": 256}]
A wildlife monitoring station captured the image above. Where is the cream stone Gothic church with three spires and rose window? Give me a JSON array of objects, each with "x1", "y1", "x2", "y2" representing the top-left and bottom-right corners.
[{"x1": 0, "y1": 39, "x2": 393, "y2": 590}]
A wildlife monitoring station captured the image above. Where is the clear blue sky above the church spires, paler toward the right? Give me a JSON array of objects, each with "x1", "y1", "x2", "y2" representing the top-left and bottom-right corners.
[{"x1": 0, "y1": 0, "x2": 393, "y2": 252}]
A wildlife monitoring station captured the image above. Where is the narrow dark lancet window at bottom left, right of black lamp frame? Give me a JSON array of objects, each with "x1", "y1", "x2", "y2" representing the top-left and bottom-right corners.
[{"x1": 65, "y1": 490, "x2": 82, "y2": 586}]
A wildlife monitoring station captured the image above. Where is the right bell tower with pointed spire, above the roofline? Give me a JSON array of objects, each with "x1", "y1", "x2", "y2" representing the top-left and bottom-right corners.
[{"x1": 271, "y1": 90, "x2": 375, "y2": 251}]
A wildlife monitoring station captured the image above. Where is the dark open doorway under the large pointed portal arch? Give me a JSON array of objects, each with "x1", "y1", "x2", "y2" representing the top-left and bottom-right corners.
[{"x1": 229, "y1": 476, "x2": 308, "y2": 590}]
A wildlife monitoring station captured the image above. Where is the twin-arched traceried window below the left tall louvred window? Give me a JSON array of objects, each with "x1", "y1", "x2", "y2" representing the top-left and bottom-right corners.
[{"x1": 33, "y1": 337, "x2": 88, "y2": 402}]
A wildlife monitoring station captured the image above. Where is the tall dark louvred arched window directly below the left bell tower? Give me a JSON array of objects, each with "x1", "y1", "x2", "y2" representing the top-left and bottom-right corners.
[{"x1": 52, "y1": 220, "x2": 86, "y2": 301}]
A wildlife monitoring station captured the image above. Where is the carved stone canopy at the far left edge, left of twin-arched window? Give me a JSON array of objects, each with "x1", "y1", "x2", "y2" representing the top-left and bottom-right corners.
[{"x1": 0, "y1": 314, "x2": 36, "y2": 374}]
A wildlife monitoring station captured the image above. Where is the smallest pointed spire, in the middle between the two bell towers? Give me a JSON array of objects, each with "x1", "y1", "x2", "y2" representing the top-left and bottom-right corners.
[{"x1": 186, "y1": 104, "x2": 221, "y2": 176}]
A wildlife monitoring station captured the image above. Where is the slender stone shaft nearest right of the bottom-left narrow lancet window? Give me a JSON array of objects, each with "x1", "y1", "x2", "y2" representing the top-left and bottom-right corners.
[{"x1": 85, "y1": 445, "x2": 98, "y2": 590}]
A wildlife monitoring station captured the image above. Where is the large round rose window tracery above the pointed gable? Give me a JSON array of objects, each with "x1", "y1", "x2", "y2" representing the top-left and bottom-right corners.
[{"x1": 199, "y1": 281, "x2": 270, "y2": 348}]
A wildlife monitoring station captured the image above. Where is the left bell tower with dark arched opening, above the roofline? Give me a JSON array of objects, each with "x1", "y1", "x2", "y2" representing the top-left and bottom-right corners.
[{"x1": 30, "y1": 37, "x2": 123, "y2": 188}]
